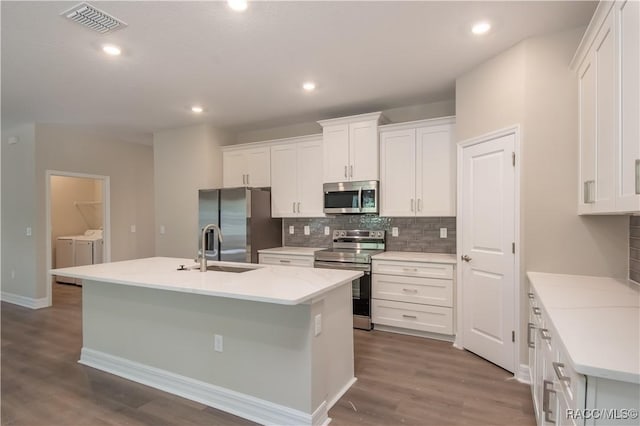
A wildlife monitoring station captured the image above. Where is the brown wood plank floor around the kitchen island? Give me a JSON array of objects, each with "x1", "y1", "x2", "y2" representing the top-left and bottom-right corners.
[{"x1": 1, "y1": 284, "x2": 535, "y2": 426}]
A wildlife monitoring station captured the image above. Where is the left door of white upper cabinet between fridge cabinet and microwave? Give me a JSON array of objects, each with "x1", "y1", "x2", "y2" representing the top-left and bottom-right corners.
[{"x1": 271, "y1": 144, "x2": 298, "y2": 217}]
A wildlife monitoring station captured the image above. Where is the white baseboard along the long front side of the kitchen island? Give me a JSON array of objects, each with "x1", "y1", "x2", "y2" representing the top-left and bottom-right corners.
[{"x1": 78, "y1": 348, "x2": 330, "y2": 426}]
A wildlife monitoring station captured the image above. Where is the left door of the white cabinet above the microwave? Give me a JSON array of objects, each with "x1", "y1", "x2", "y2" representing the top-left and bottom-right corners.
[{"x1": 322, "y1": 124, "x2": 349, "y2": 182}]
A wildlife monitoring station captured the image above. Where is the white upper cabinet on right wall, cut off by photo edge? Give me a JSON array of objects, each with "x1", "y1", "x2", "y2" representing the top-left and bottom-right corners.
[{"x1": 572, "y1": 0, "x2": 640, "y2": 214}]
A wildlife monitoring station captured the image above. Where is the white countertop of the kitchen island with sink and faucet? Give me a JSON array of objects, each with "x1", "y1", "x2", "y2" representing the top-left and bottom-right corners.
[{"x1": 51, "y1": 257, "x2": 362, "y2": 305}]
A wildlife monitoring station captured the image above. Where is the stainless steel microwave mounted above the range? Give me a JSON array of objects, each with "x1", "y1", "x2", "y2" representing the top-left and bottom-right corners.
[{"x1": 323, "y1": 180, "x2": 379, "y2": 214}]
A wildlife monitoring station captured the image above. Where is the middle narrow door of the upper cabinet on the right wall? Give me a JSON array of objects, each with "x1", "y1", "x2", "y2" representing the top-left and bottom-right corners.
[{"x1": 594, "y1": 13, "x2": 616, "y2": 213}]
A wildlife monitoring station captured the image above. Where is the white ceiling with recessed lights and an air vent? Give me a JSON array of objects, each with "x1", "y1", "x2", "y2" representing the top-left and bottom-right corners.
[{"x1": 1, "y1": 1, "x2": 595, "y2": 140}]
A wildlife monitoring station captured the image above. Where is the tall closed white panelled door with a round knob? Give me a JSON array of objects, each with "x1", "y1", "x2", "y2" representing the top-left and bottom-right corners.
[{"x1": 459, "y1": 134, "x2": 516, "y2": 372}]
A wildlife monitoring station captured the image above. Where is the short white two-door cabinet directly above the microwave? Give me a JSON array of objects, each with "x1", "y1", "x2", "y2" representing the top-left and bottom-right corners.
[{"x1": 318, "y1": 112, "x2": 382, "y2": 182}]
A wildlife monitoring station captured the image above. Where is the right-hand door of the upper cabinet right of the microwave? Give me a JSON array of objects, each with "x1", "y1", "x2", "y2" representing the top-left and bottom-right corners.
[{"x1": 416, "y1": 126, "x2": 456, "y2": 216}]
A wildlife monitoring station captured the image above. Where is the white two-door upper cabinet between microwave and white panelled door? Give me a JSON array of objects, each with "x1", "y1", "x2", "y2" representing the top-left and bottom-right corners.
[{"x1": 380, "y1": 118, "x2": 456, "y2": 217}]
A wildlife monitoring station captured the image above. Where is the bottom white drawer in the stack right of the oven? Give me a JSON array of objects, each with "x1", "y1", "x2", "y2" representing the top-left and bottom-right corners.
[{"x1": 371, "y1": 299, "x2": 453, "y2": 334}]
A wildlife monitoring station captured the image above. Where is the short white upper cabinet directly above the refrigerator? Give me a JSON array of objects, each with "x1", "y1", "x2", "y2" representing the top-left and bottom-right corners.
[{"x1": 222, "y1": 146, "x2": 271, "y2": 188}]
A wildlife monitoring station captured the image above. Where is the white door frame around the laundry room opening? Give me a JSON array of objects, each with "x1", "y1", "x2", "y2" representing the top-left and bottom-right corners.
[{"x1": 45, "y1": 170, "x2": 111, "y2": 306}]
